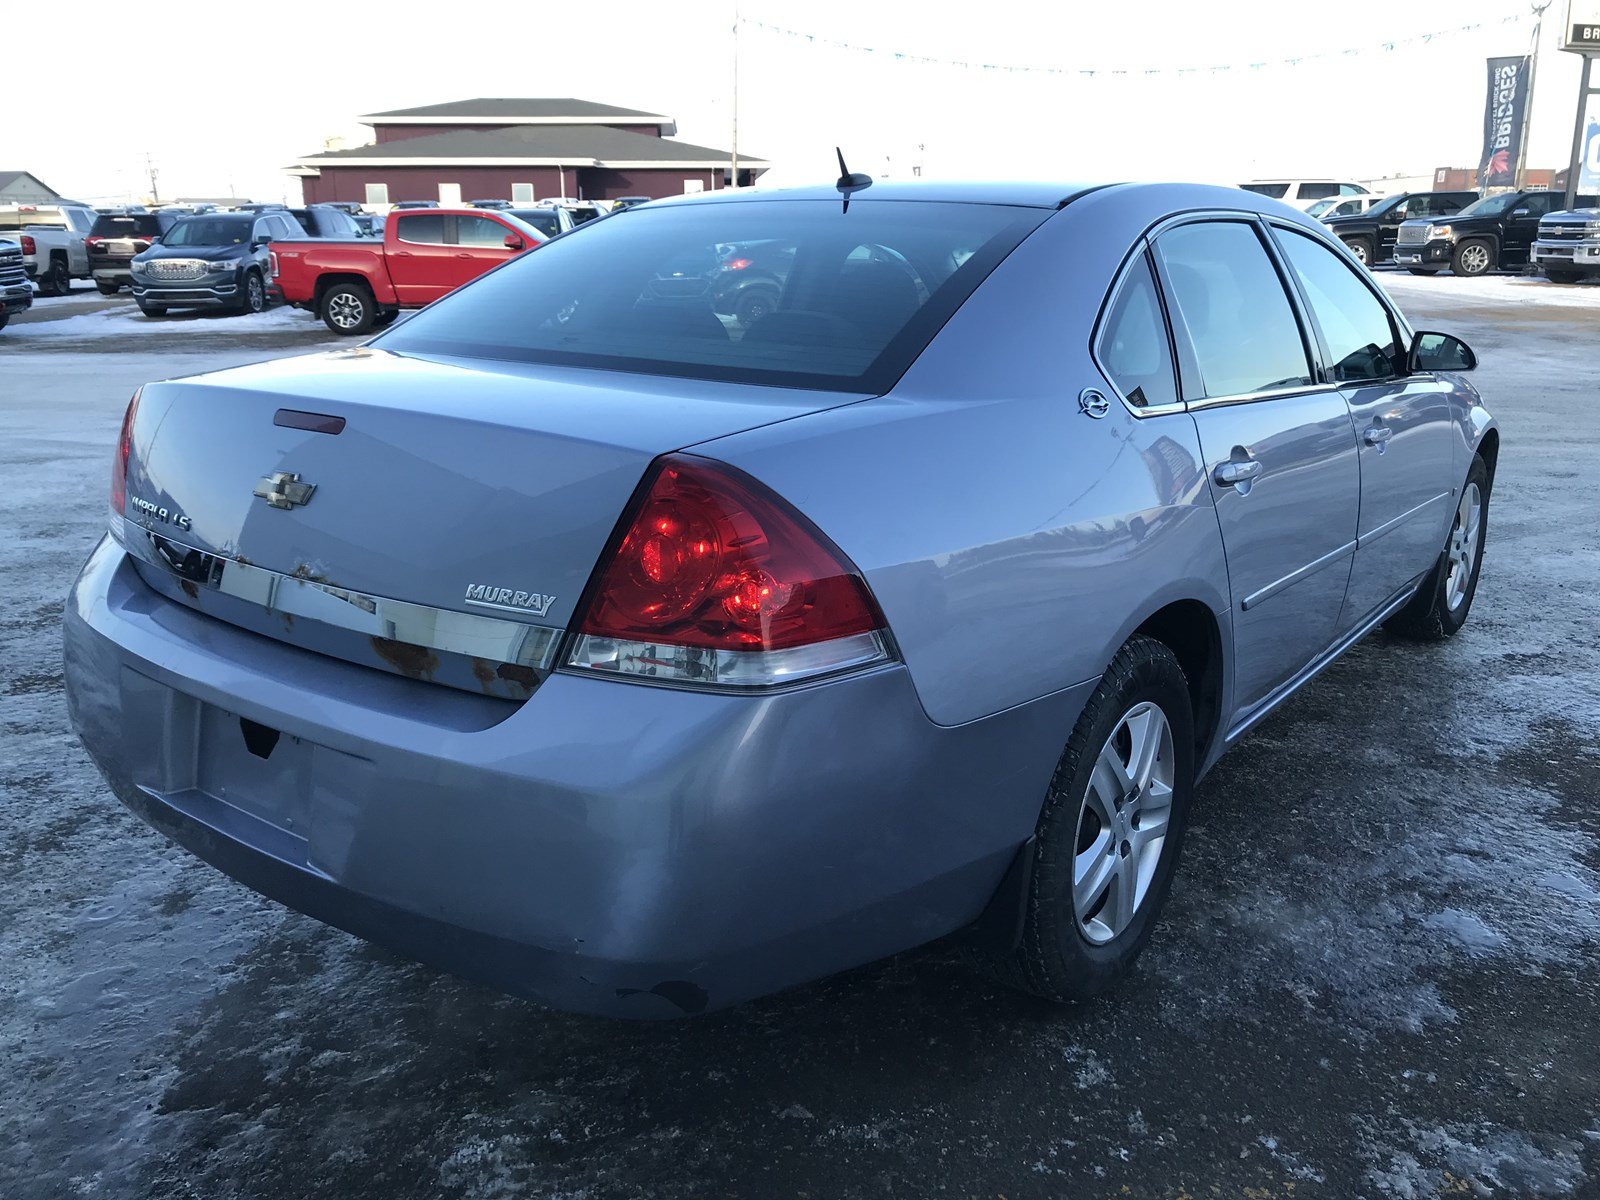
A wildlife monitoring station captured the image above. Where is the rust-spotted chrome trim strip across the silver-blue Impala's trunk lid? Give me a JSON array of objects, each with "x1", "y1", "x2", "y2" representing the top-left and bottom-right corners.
[{"x1": 110, "y1": 514, "x2": 565, "y2": 672}]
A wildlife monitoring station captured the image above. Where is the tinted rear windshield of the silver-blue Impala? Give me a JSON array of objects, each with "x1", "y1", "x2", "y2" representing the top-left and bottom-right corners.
[{"x1": 381, "y1": 198, "x2": 1050, "y2": 392}]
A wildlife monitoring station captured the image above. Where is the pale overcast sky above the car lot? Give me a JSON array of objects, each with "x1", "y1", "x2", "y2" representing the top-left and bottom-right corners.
[{"x1": 18, "y1": 0, "x2": 1579, "y2": 200}]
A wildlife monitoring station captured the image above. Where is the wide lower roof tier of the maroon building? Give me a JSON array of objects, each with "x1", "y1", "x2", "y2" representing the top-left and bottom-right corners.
[{"x1": 296, "y1": 125, "x2": 766, "y2": 168}]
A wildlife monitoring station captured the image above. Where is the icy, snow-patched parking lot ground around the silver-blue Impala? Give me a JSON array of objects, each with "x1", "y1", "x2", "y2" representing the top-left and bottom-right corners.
[{"x1": 0, "y1": 274, "x2": 1600, "y2": 1200}]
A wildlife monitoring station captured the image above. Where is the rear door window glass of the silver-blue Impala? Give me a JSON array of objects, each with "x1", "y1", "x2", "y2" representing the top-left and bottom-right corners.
[{"x1": 1157, "y1": 221, "x2": 1312, "y2": 397}]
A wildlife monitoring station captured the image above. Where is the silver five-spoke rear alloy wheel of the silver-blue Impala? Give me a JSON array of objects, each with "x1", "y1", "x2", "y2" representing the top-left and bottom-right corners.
[{"x1": 1072, "y1": 701, "x2": 1176, "y2": 946}]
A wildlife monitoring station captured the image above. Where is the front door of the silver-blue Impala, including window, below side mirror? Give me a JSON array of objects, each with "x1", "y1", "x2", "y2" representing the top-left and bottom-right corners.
[{"x1": 1274, "y1": 226, "x2": 1456, "y2": 632}]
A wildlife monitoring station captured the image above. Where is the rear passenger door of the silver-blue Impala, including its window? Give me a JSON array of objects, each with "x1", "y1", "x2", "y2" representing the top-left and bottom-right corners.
[{"x1": 1155, "y1": 216, "x2": 1360, "y2": 714}]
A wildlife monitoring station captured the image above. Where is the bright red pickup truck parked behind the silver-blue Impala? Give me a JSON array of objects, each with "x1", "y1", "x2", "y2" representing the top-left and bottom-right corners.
[{"x1": 272, "y1": 208, "x2": 546, "y2": 336}]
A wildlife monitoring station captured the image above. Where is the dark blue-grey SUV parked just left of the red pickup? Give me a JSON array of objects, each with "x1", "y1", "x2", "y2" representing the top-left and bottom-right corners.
[{"x1": 133, "y1": 210, "x2": 306, "y2": 317}]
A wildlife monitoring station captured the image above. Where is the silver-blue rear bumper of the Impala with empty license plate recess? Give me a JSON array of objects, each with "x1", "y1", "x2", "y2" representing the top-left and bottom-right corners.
[{"x1": 66, "y1": 541, "x2": 1086, "y2": 1018}]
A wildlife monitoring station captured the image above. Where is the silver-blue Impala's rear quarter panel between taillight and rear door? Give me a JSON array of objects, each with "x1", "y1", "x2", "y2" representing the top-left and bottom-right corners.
[{"x1": 699, "y1": 192, "x2": 1230, "y2": 723}]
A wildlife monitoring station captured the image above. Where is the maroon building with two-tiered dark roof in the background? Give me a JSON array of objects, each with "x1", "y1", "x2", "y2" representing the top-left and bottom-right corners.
[{"x1": 290, "y1": 98, "x2": 766, "y2": 205}]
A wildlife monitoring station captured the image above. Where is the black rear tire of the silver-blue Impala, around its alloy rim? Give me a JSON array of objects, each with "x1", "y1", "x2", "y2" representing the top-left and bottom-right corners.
[{"x1": 981, "y1": 637, "x2": 1194, "y2": 1002}]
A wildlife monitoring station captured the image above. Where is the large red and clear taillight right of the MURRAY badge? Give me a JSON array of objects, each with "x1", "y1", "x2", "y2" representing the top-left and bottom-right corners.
[{"x1": 568, "y1": 456, "x2": 888, "y2": 686}]
